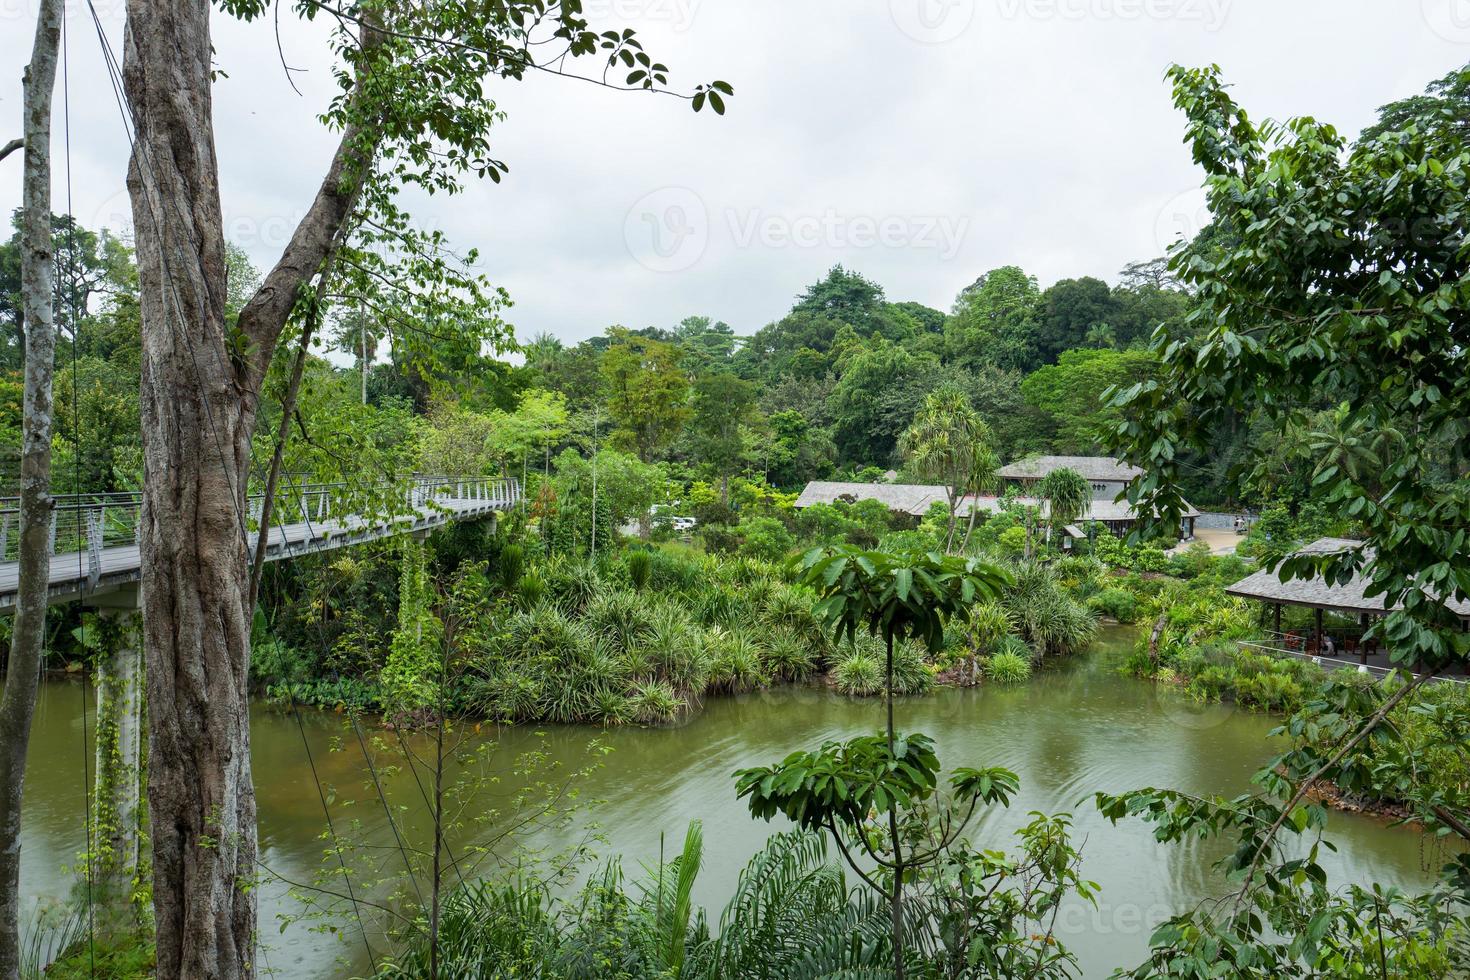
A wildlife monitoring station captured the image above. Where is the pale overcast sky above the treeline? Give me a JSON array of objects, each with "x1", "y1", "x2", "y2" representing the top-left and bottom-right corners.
[{"x1": 0, "y1": 0, "x2": 1470, "y2": 341}]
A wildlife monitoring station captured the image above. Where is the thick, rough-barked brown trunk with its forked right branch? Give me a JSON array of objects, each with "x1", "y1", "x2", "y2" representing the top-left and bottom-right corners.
[{"x1": 123, "y1": 0, "x2": 370, "y2": 980}]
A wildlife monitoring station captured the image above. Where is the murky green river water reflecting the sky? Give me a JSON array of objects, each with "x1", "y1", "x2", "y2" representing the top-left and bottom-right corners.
[{"x1": 22, "y1": 630, "x2": 1442, "y2": 977}]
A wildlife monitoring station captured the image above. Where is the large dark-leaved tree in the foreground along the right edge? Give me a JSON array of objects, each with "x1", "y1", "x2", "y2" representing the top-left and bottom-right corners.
[{"x1": 1100, "y1": 66, "x2": 1470, "y2": 977}]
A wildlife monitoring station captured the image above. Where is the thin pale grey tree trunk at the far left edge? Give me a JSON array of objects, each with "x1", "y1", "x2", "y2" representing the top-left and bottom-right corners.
[{"x1": 0, "y1": 0, "x2": 62, "y2": 980}]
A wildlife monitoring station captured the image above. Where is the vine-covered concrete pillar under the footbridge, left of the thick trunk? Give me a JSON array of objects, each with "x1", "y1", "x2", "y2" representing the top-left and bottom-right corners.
[{"x1": 88, "y1": 585, "x2": 146, "y2": 914}]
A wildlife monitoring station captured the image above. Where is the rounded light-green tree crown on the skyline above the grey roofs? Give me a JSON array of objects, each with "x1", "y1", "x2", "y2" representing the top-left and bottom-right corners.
[{"x1": 944, "y1": 266, "x2": 1041, "y2": 369}]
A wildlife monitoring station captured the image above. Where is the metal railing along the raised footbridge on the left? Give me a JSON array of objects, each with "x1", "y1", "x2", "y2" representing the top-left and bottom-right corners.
[{"x1": 0, "y1": 476, "x2": 520, "y2": 574}]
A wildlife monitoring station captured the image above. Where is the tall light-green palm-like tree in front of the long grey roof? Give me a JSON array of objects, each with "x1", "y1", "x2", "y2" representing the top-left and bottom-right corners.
[{"x1": 898, "y1": 386, "x2": 998, "y2": 551}]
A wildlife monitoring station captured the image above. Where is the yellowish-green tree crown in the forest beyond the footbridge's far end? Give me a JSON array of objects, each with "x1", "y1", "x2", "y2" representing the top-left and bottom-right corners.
[{"x1": 601, "y1": 329, "x2": 689, "y2": 463}]
